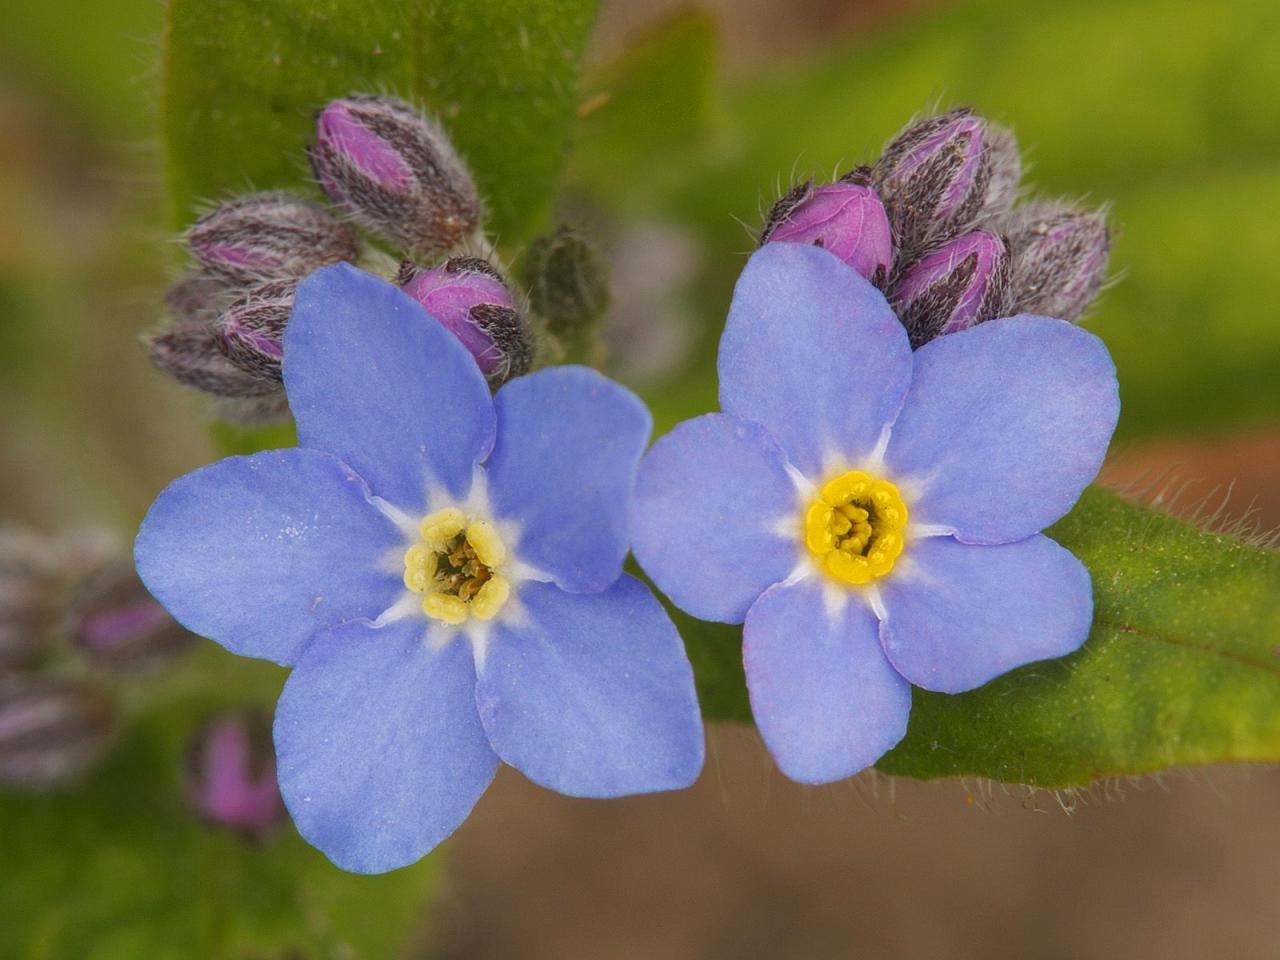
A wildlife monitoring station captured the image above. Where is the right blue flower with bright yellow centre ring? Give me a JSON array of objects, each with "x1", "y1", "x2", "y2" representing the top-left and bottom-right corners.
[{"x1": 632, "y1": 243, "x2": 1120, "y2": 783}]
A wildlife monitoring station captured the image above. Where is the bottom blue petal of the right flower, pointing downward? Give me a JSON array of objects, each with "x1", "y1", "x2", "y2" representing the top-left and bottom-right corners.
[{"x1": 742, "y1": 579, "x2": 911, "y2": 783}]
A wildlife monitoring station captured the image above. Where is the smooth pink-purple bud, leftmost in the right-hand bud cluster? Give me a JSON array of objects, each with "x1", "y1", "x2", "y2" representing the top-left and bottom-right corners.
[{"x1": 760, "y1": 168, "x2": 893, "y2": 285}]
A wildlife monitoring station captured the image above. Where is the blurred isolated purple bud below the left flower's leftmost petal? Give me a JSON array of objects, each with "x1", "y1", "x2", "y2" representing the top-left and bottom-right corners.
[{"x1": 187, "y1": 710, "x2": 284, "y2": 838}]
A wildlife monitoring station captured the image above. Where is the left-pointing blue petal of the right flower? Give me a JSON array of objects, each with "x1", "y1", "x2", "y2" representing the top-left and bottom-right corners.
[{"x1": 631, "y1": 413, "x2": 799, "y2": 623}]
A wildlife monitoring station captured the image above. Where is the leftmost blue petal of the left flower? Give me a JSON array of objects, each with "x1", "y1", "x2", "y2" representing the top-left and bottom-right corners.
[{"x1": 134, "y1": 449, "x2": 403, "y2": 664}]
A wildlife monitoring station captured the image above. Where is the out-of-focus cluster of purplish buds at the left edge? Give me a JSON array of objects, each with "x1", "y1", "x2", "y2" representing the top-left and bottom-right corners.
[{"x1": 0, "y1": 529, "x2": 192, "y2": 788}]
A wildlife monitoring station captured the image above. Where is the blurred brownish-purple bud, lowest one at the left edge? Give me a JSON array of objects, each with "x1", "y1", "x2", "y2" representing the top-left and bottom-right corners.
[{"x1": 0, "y1": 675, "x2": 115, "y2": 788}]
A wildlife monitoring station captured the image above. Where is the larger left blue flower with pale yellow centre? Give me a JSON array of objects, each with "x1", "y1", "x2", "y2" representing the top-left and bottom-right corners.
[{"x1": 136, "y1": 265, "x2": 703, "y2": 873}]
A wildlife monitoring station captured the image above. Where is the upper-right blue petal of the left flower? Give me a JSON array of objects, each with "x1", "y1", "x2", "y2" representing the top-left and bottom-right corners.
[{"x1": 485, "y1": 366, "x2": 653, "y2": 593}]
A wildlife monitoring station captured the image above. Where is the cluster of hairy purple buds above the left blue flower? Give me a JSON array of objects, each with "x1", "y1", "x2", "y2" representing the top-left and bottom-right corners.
[{"x1": 147, "y1": 96, "x2": 545, "y2": 422}]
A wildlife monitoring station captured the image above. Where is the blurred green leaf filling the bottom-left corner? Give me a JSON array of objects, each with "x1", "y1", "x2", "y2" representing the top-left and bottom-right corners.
[{"x1": 0, "y1": 644, "x2": 440, "y2": 960}]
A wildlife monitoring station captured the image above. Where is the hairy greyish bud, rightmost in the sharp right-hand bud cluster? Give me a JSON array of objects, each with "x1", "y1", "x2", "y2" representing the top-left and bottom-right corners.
[{"x1": 1007, "y1": 204, "x2": 1111, "y2": 323}]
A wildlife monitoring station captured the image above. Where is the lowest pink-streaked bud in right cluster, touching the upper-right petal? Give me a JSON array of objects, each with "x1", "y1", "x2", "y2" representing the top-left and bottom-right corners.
[{"x1": 890, "y1": 230, "x2": 1009, "y2": 347}]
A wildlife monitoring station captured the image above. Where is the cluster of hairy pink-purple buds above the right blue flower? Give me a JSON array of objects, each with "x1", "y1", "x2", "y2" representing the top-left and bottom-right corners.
[{"x1": 760, "y1": 108, "x2": 1110, "y2": 347}]
